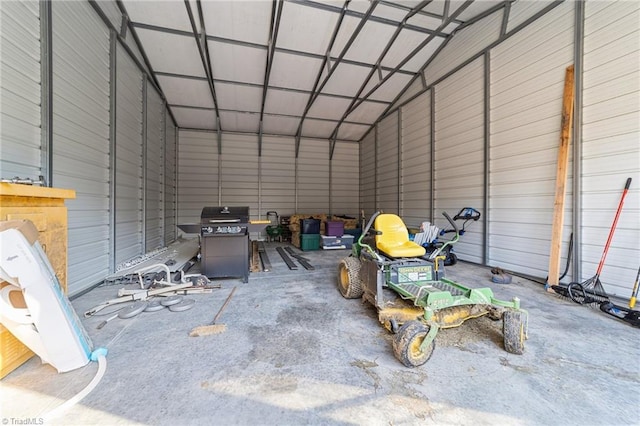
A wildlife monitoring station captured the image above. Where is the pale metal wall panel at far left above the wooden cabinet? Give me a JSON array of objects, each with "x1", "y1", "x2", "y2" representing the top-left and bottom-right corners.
[{"x1": 0, "y1": 1, "x2": 42, "y2": 180}]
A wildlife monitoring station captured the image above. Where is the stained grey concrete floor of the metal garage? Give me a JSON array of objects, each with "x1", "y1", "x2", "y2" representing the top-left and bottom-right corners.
[{"x1": 0, "y1": 243, "x2": 640, "y2": 425}]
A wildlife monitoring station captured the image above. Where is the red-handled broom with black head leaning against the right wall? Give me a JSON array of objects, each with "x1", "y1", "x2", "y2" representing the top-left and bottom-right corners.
[{"x1": 551, "y1": 178, "x2": 631, "y2": 305}]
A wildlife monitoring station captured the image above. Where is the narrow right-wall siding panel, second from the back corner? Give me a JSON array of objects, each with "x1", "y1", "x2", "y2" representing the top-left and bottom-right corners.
[{"x1": 376, "y1": 112, "x2": 399, "y2": 214}]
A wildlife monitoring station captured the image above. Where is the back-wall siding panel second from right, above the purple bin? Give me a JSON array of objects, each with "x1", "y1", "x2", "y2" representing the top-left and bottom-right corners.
[{"x1": 297, "y1": 139, "x2": 329, "y2": 214}]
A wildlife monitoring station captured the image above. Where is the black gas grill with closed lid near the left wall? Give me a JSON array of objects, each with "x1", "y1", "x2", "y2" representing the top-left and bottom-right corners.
[{"x1": 200, "y1": 207, "x2": 249, "y2": 283}]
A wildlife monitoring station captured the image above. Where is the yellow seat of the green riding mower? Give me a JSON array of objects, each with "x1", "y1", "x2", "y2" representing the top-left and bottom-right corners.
[{"x1": 373, "y1": 214, "x2": 426, "y2": 257}]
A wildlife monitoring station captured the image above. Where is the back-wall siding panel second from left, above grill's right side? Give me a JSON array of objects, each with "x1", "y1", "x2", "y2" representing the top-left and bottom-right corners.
[{"x1": 220, "y1": 133, "x2": 259, "y2": 219}]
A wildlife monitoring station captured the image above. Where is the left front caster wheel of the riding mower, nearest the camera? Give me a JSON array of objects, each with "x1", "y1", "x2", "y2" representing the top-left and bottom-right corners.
[{"x1": 393, "y1": 321, "x2": 436, "y2": 367}]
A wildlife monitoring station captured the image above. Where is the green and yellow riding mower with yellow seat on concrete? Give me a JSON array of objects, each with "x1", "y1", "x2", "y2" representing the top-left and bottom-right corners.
[{"x1": 338, "y1": 212, "x2": 528, "y2": 367}]
